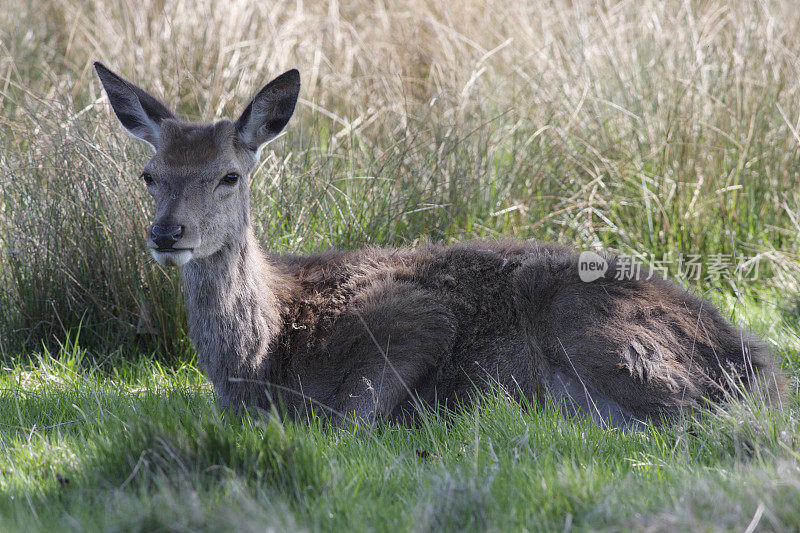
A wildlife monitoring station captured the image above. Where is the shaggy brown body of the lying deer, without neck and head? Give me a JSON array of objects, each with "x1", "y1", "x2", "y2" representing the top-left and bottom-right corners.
[{"x1": 262, "y1": 242, "x2": 782, "y2": 426}]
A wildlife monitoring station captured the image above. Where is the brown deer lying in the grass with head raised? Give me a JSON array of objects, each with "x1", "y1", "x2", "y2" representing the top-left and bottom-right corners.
[{"x1": 95, "y1": 63, "x2": 783, "y2": 427}]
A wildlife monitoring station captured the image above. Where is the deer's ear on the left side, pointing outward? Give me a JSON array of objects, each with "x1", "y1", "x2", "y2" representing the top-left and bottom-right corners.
[{"x1": 94, "y1": 61, "x2": 175, "y2": 149}]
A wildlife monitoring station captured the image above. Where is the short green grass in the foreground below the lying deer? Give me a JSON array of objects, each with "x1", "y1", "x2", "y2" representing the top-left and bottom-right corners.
[{"x1": 0, "y1": 304, "x2": 800, "y2": 531}]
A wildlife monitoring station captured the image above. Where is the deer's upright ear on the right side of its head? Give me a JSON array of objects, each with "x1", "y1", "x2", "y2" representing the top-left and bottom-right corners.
[{"x1": 236, "y1": 69, "x2": 300, "y2": 152}]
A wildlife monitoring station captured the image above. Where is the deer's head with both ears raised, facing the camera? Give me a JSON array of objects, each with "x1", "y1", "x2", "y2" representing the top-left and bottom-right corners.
[{"x1": 94, "y1": 62, "x2": 300, "y2": 266}]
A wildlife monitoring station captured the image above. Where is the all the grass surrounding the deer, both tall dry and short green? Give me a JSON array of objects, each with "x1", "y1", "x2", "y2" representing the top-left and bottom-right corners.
[{"x1": 0, "y1": 0, "x2": 800, "y2": 531}]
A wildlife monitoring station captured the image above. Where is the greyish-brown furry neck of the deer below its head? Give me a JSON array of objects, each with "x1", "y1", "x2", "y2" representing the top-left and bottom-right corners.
[{"x1": 182, "y1": 226, "x2": 287, "y2": 405}]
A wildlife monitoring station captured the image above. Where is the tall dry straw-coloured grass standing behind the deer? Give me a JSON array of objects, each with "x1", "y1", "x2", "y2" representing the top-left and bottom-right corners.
[{"x1": 0, "y1": 0, "x2": 800, "y2": 354}]
